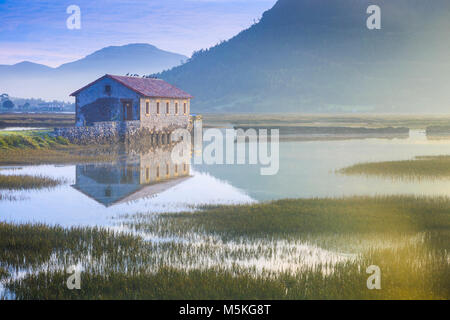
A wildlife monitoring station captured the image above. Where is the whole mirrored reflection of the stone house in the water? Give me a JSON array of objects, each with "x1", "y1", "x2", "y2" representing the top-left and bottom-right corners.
[{"x1": 72, "y1": 148, "x2": 190, "y2": 207}]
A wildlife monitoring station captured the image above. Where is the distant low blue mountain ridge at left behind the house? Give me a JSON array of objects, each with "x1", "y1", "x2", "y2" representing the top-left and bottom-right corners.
[{"x1": 0, "y1": 43, "x2": 188, "y2": 101}]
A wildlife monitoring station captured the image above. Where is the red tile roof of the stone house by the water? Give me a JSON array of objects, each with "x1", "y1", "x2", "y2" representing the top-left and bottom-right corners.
[{"x1": 71, "y1": 74, "x2": 193, "y2": 99}]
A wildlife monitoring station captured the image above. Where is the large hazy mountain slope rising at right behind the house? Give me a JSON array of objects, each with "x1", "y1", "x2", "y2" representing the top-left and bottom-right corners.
[{"x1": 157, "y1": 0, "x2": 450, "y2": 112}]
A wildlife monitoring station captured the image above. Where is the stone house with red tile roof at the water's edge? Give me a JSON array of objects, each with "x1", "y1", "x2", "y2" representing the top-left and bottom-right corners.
[{"x1": 71, "y1": 74, "x2": 192, "y2": 132}]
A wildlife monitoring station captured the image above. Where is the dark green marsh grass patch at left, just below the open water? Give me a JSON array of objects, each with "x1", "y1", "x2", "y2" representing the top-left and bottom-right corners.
[{"x1": 0, "y1": 223, "x2": 145, "y2": 270}]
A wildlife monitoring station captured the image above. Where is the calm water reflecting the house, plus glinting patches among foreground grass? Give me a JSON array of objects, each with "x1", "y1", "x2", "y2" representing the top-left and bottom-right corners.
[{"x1": 0, "y1": 131, "x2": 450, "y2": 299}]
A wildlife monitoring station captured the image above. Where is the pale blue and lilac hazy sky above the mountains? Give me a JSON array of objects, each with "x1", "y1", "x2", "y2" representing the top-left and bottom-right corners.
[{"x1": 0, "y1": 0, "x2": 276, "y2": 66}]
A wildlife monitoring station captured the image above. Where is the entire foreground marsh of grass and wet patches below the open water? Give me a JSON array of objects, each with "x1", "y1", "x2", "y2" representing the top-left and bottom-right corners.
[{"x1": 0, "y1": 196, "x2": 450, "y2": 299}]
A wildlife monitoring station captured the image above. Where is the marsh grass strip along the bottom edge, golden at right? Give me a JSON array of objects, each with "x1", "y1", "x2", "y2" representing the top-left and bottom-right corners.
[{"x1": 2, "y1": 230, "x2": 450, "y2": 299}]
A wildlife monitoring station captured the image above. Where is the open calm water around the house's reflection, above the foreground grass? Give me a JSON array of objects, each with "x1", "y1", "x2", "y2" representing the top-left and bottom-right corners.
[{"x1": 0, "y1": 131, "x2": 450, "y2": 226}]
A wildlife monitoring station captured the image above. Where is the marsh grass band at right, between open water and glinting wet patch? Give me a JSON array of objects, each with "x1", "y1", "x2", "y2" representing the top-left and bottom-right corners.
[{"x1": 149, "y1": 196, "x2": 450, "y2": 238}]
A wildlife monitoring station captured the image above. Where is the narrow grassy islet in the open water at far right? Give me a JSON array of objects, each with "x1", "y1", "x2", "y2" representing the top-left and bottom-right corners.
[{"x1": 338, "y1": 156, "x2": 450, "y2": 180}]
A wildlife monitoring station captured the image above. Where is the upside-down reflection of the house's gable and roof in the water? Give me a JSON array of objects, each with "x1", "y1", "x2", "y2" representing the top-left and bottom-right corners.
[{"x1": 72, "y1": 176, "x2": 191, "y2": 207}]
